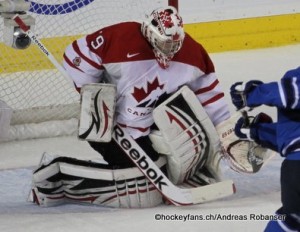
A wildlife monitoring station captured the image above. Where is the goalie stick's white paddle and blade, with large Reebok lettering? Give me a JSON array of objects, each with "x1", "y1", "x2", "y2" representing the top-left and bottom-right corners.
[{"x1": 113, "y1": 125, "x2": 235, "y2": 206}]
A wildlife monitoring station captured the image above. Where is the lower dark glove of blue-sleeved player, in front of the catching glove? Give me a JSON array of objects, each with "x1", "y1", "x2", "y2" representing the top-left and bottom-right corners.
[{"x1": 234, "y1": 113, "x2": 273, "y2": 144}]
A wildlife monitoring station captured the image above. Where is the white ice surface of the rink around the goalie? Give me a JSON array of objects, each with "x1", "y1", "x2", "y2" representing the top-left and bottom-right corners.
[{"x1": 0, "y1": 45, "x2": 300, "y2": 232}]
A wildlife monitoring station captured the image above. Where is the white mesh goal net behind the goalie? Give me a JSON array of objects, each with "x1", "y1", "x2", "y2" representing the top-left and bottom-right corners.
[{"x1": 0, "y1": 0, "x2": 168, "y2": 141}]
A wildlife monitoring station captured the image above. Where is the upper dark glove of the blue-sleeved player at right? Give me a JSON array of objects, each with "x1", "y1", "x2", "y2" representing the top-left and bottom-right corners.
[{"x1": 230, "y1": 80, "x2": 263, "y2": 110}]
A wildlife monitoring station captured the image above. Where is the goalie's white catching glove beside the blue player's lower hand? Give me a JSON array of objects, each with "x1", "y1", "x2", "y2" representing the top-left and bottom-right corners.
[{"x1": 216, "y1": 111, "x2": 275, "y2": 173}]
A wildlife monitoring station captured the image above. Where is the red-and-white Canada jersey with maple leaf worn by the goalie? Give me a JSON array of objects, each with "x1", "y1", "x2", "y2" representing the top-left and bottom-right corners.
[{"x1": 64, "y1": 22, "x2": 229, "y2": 138}]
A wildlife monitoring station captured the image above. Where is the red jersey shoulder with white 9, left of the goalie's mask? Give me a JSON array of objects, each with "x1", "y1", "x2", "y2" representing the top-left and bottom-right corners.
[{"x1": 86, "y1": 22, "x2": 153, "y2": 64}]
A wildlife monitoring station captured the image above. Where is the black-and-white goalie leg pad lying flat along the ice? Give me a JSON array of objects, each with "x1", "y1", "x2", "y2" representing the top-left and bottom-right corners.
[{"x1": 29, "y1": 154, "x2": 165, "y2": 208}]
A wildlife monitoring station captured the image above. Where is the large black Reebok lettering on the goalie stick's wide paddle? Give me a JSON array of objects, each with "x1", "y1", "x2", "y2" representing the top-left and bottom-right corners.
[{"x1": 114, "y1": 125, "x2": 168, "y2": 190}]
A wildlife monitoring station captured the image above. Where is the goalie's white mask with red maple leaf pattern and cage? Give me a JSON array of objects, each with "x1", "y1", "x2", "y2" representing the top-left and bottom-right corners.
[{"x1": 142, "y1": 6, "x2": 184, "y2": 68}]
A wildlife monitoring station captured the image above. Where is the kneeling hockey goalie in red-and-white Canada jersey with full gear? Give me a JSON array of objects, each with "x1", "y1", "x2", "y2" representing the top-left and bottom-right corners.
[{"x1": 25, "y1": 7, "x2": 268, "y2": 208}]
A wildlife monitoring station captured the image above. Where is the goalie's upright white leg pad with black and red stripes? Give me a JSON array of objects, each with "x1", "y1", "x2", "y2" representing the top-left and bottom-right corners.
[{"x1": 150, "y1": 86, "x2": 220, "y2": 184}]
